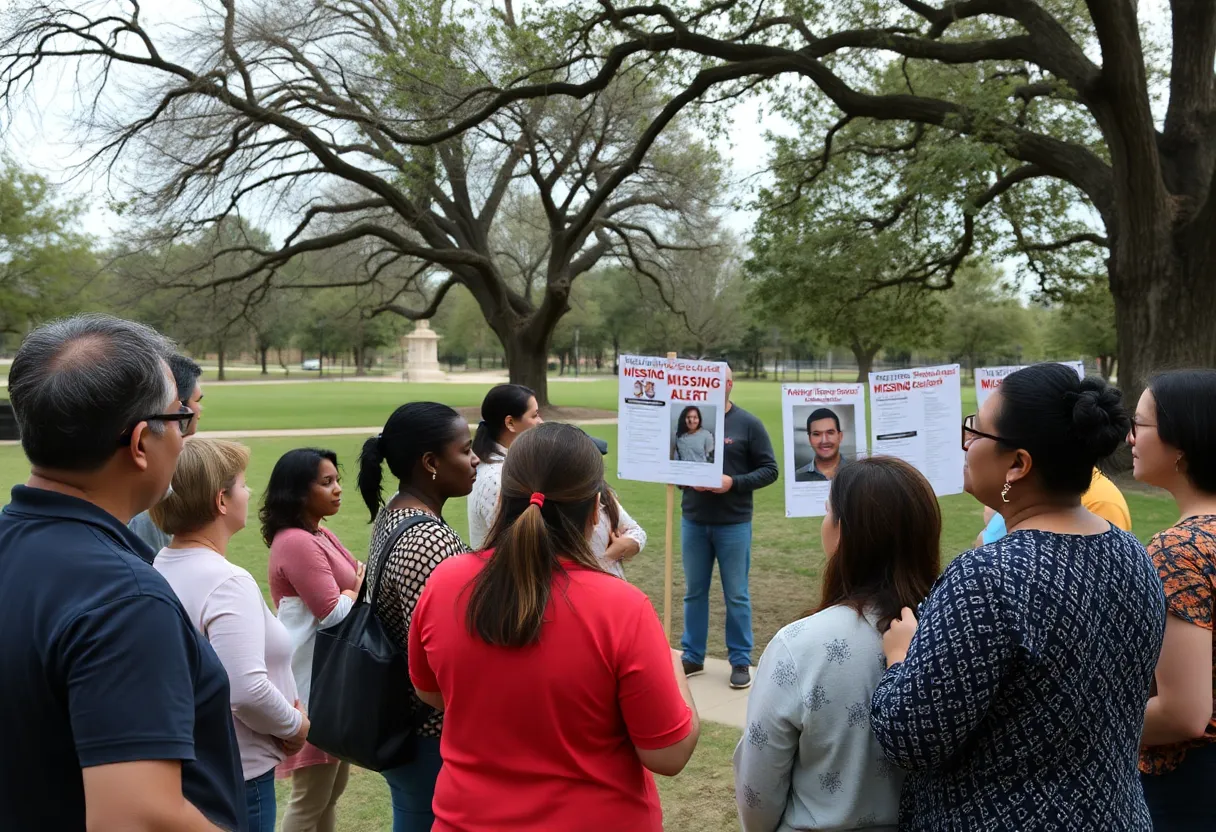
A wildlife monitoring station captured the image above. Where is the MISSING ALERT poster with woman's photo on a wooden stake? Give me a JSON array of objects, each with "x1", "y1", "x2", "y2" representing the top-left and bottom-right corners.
[{"x1": 617, "y1": 355, "x2": 727, "y2": 488}]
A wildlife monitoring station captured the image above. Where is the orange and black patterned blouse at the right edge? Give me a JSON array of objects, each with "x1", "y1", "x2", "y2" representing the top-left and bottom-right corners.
[{"x1": 1141, "y1": 515, "x2": 1216, "y2": 775}]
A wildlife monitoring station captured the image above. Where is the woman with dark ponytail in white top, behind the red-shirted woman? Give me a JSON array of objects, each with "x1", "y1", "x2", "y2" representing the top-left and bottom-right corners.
[{"x1": 468, "y1": 384, "x2": 545, "y2": 550}]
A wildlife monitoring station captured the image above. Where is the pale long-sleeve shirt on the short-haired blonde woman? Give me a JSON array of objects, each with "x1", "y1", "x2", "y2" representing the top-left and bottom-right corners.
[{"x1": 153, "y1": 549, "x2": 303, "y2": 780}]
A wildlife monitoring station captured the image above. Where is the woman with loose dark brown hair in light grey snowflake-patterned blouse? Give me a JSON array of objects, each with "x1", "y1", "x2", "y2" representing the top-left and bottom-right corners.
[{"x1": 734, "y1": 456, "x2": 941, "y2": 832}]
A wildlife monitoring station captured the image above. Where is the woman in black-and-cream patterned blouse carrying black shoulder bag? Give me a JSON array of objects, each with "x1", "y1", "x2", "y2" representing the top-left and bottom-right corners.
[{"x1": 359, "y1": 401, "x2": 478, "y2": 832}]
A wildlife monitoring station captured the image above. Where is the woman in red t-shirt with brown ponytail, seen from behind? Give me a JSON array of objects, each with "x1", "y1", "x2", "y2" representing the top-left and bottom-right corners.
[{"x1": 410, "y1": 425, "x2": 700, "y2": 832}]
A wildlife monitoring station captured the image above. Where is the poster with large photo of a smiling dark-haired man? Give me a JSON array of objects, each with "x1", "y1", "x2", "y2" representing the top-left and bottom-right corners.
[{"x1": 781, "y1": 384, "x2": 866, "y2": 517}]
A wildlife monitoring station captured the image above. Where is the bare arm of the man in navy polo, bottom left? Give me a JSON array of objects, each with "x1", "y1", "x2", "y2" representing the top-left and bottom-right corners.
[{"x1": 81, "y1": 760, "x2": 225, "y2": 832}]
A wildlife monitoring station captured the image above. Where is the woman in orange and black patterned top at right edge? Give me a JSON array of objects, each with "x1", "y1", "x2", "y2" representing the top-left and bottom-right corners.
[{"x1": 1128, "y1": 370, "x2": 1216, "y2": 832}]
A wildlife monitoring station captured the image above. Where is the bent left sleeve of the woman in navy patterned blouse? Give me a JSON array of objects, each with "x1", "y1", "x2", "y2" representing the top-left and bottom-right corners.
[{"x1": 869, "y1": 551, "x2": 1015, "y2": 770}]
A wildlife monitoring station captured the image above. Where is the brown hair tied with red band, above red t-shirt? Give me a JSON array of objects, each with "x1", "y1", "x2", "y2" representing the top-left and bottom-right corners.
[{"x1": 466, "y1": 423, "x2": 604, "y2": 647}]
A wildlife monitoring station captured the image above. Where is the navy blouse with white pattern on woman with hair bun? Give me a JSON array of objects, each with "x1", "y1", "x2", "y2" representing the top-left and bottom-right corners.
[{"x1": 871, "y1": 529, "x2": 1165, "y2": 832}]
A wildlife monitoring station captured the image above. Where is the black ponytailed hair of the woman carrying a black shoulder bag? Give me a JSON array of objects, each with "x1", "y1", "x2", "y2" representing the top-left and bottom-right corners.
[{"x1": 359, "y1": 401, "x2": 468, "y2": 521}]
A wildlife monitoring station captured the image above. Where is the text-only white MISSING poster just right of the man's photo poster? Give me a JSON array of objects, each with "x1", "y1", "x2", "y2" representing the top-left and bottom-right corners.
[{"x1": 869, "y1": 364, "x2": 963, "y2": 496}]
